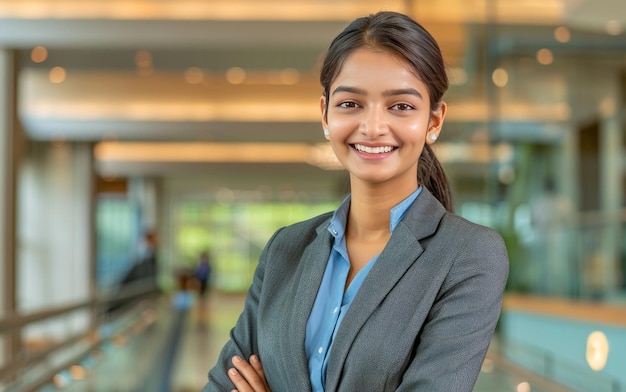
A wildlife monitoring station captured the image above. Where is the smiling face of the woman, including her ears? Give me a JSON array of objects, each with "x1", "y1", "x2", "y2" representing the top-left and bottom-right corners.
[{"x1": 321, "y1": 49, "x2": 446, "y2": 187}]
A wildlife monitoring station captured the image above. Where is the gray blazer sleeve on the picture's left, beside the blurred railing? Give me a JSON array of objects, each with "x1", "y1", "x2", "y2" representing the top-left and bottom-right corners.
[{"x1": 202, "y1": 229, "x2": 282, "y2": 392}]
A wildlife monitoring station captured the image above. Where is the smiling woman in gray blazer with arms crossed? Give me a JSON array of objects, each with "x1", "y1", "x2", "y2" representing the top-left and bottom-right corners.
[{"x1": 204, "y1": 12, "x2": 508, "y2": 392}]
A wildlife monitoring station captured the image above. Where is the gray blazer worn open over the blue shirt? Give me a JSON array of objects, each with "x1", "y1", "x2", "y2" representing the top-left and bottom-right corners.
[{"x1": 203, "y1": 189, "x2": 509, "y2": 392}]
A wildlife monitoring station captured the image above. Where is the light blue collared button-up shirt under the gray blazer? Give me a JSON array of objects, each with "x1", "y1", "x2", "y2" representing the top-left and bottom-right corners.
[{"x1": 305, "y1": 186, "x2": 422, "y2": 392}]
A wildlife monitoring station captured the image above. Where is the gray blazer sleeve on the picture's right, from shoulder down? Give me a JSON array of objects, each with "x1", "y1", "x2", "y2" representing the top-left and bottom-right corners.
[{"x1": 397, "y1": 227, "x2": 509, "y2": 392}]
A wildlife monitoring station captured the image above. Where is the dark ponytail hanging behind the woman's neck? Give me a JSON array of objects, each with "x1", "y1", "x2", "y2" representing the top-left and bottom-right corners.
[{"x1": 417, "y1": 144, "x2": 454, "y2": 212}]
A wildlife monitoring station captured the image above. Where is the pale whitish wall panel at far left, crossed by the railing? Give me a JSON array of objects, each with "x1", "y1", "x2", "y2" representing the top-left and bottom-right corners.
[{"x1": 16, "y1": 142, "x2": 93, "y2": 339}]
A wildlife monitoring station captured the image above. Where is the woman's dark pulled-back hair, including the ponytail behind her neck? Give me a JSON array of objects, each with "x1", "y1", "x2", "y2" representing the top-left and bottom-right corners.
[{"x1": 320, "y1": 11, "x2": 453, "y2": 211}]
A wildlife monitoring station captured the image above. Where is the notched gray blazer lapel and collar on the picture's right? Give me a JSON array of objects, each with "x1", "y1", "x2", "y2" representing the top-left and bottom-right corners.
[{"x1": 326, "y1": 188, "x2": 445, "y2": 391}]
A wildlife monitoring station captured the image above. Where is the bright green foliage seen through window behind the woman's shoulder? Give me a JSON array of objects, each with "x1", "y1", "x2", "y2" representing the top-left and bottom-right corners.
[{"x1": 173, "y1": 201, "x2": 339, "y2": 292}]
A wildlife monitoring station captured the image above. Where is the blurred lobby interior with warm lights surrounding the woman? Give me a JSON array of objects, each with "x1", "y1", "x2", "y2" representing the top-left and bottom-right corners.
[{"x1": 0, "y1": 0, "x2": 626, "y2": 392}]
